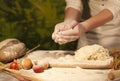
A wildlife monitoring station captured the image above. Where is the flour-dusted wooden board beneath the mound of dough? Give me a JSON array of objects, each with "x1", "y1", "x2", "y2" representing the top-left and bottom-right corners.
[{"x1": 28, "y1": 50, "x2": 111, "y2": 69}]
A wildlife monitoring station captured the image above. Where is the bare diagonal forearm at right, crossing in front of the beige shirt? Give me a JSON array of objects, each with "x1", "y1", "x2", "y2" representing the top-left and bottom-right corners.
[{"x1": 81, "y1": 9, "x2": 113, "y2": 31}]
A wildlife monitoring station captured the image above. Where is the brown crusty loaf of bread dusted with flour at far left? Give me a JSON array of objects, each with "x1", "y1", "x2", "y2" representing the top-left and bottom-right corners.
[{"x1": 0, "y1": 38, "x2": 27, "y2": 63}]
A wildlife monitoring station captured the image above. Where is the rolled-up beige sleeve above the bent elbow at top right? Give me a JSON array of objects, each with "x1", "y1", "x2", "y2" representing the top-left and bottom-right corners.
[{"x1": 104, "y1": 0, "x2": 120, "y2": 19}]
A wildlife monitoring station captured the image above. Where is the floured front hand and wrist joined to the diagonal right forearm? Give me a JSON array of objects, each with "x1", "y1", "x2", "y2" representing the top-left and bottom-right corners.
[{"x1": 57, "y1": 22, "x2": 87, "y2": 44}]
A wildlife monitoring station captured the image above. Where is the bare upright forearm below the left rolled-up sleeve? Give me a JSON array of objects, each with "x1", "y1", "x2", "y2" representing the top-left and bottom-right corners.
[{"x1": 64, "y1": 7, "x2": 81, "y2": 22}]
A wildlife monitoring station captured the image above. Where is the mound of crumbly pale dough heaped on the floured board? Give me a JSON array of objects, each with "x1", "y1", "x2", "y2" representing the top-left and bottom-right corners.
[{"x1": 75, "y1": 44, "x2": 110, "y2": 60}]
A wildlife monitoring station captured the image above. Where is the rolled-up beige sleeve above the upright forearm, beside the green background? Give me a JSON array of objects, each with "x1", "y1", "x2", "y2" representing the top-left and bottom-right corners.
[{"x1": 65, "y1": 0, "x2": 83, "y2": 11}]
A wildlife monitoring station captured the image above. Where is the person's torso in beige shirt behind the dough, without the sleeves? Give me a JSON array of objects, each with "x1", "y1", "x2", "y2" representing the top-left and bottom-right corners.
[{"x1": 78, "y1": 0, "x2": 120, "y2": 49}]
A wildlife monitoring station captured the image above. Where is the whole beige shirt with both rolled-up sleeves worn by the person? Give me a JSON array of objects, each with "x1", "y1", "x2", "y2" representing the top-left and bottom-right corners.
[{"x1": 66, "y1": 0, "x2": 120, "y2": 49}]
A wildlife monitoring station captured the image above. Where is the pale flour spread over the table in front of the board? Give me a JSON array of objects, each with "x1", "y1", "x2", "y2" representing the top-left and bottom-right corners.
[{"x1": 22, "y1": 67, "x2": 108, "y2": 81}]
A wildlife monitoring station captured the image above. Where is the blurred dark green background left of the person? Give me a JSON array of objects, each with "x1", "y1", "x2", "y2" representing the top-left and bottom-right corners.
[{"x1": 0, "y1": 0, "x2": 77, "y2": 50}]
